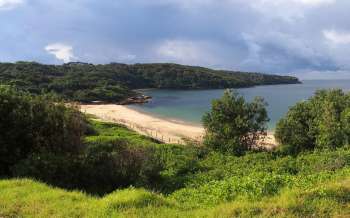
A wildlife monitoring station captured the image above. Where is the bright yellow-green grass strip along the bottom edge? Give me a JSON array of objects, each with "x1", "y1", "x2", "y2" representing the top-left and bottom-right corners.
[{"x1": 0, "y1": 175, "x2": 350, "y2": 217}]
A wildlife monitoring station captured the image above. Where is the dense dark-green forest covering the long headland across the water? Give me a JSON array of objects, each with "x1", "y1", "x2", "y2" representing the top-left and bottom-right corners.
[{"x1": 0, "y1": 62, "x2": 299, "y2": 102}]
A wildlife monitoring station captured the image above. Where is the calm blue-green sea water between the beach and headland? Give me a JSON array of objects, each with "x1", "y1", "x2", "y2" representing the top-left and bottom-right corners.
[{"x1": 130, "y1": 80, "x2": 350, "y2": 130}]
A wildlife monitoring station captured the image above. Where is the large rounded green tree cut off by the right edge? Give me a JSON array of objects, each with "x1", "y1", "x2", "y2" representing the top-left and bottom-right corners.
[{"x1": 275, "y1": 90, "x2": 350, "y2": 154}]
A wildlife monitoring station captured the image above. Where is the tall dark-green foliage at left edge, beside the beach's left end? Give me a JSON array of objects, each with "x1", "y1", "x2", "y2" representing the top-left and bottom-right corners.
[{"x1": 0, "y1": 86, "x2": 85, "y2": 175}]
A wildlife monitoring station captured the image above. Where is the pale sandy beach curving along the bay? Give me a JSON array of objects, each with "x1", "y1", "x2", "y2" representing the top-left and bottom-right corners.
[{"x1": 80, "y1": 104, "x2": 276, "y2": 149}]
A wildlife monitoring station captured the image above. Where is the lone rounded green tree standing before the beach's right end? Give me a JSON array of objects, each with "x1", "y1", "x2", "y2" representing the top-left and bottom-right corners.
[{"x1": 203, "y1": 90, "x2": 269, "y2": 155}]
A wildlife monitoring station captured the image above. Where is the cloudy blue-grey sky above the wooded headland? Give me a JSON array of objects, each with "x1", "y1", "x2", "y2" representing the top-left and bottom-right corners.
[{"x1": 0, "y1": 0, "x2": 350, "y2": 79}]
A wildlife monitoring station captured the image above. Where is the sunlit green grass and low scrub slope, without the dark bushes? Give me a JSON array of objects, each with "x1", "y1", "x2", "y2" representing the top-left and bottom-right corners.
[{"x1": 0, "y1": 121, "x2": 350, "y2": 217}]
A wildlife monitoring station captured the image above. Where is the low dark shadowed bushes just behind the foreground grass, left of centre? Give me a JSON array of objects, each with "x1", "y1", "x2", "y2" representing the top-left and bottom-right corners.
[{"x1": 12, "y1": 140, "x2": 163, "y2": 195}]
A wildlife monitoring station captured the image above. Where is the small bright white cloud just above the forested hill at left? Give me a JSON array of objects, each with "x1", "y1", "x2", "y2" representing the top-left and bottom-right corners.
[{"x1": 45, "y1": 43, "x2": 76, "y2": 63}]
